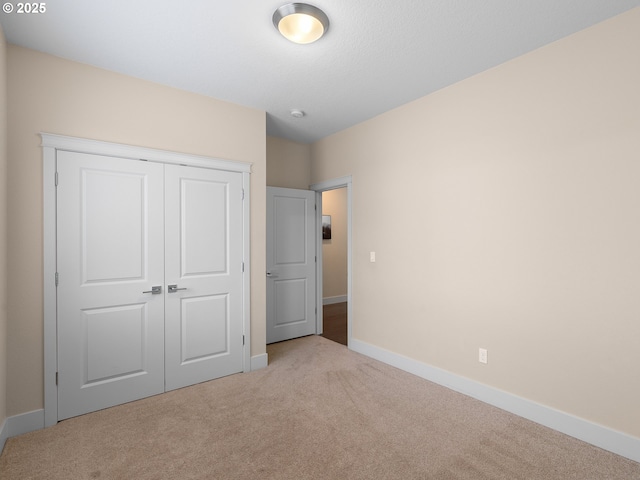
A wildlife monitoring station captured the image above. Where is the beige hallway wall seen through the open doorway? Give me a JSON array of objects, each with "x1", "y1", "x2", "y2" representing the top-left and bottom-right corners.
[{"x1": 322, "y1": 188, "x2": 348, "y2": 298}]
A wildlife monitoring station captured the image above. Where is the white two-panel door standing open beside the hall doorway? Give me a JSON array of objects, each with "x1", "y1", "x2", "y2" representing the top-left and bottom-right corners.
[{"x1": 267, "y1": 187, "x2": 316, "y2": 343}]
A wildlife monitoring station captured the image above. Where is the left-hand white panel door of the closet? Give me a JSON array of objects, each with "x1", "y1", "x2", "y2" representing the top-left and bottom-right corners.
[{"x1": 57, "y1": 152, "x2": 164, "y2": 420}]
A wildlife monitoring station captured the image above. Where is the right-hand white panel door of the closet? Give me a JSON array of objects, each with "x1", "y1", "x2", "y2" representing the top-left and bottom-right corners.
[{"x1": 165, "y1": 165, "x2": 243, "y2": 390}]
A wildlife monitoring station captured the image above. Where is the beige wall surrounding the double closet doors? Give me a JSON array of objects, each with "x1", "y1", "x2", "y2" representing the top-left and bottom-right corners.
[{"x1": 7, "y1": 45, "x2": 266, "y2": 415}]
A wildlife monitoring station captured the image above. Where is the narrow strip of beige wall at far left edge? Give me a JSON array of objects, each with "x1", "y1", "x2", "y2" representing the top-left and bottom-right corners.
[{"x1": 0, "y1": 22, "x2": 7, "y2": 428}]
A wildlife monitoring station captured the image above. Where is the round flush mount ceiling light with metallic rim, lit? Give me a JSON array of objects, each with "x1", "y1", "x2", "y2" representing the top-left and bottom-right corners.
[{"x1": 273, "y1": 3, "x2": 329, "y2": 44}]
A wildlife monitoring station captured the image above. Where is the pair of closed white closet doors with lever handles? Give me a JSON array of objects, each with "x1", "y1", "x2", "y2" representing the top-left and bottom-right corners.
[{"x1": 56, "y1": 151, "x2": 244, "y2": 420}]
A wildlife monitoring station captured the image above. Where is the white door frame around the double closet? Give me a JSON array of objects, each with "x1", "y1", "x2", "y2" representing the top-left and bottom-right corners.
[{"x1": 40, "y1": 133, "x2": 252, "y2": 427}]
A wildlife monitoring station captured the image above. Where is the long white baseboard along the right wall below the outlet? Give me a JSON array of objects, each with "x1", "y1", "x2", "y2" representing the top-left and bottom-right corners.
[{"x1": 349, "y1": 339, "x2": 640, "y2": 462}]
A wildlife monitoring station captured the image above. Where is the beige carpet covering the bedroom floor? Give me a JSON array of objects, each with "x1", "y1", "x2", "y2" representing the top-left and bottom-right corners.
[{"x1": 0, "y1": 336, "x2": 640, "y2": 480}]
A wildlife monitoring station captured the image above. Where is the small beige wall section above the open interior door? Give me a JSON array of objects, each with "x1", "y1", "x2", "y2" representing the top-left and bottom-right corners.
[{"x1": 267, "y1": 137, "x2": 311, "y2": 190}]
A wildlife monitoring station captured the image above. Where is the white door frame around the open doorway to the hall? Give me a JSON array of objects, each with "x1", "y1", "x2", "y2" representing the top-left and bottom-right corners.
[{"x1": 309, "y1": 175, "x2": 353, "y2": 348}]
